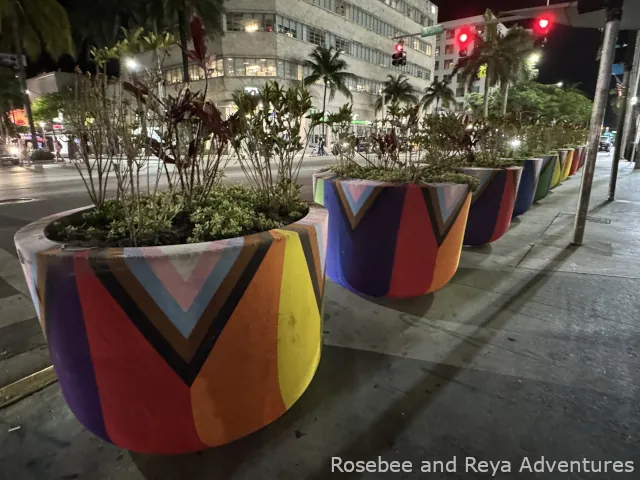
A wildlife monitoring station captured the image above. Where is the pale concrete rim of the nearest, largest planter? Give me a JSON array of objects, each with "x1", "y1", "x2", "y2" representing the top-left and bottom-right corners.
[{"x1": 14, "y1": 202, "x2": 327, "y2": 258}]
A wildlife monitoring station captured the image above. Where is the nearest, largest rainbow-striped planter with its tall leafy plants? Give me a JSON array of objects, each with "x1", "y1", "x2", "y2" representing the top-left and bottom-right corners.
[{"x1": 15, "y1": 19, "x2": 327, "y2": 454}]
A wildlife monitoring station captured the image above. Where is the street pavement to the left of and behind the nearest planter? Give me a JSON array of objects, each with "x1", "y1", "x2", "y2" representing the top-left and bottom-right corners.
[{"x1": 0, "y1": 157, "x2": 335, "y2": 387}]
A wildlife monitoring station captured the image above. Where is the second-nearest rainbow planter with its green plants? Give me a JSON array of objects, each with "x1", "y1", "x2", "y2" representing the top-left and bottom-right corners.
[{"x1": 316, "y1": 105, "x2": 476, "y2": 298}]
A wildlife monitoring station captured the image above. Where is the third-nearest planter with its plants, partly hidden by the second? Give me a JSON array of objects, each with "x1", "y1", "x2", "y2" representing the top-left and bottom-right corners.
[{"x1": 461, "y1": 117, "x2": 524, "y2": 245}]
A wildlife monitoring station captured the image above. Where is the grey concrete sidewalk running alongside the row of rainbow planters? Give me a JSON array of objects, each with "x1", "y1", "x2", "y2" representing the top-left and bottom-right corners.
[{"x1": 0, "y1": 157, "x2": 640, "y2": 480}]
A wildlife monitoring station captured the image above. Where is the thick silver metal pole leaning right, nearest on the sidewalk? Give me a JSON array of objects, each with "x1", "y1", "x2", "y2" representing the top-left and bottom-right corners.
[{"x1": 572, "y1": 7, "x2": 622, "y2": 245}]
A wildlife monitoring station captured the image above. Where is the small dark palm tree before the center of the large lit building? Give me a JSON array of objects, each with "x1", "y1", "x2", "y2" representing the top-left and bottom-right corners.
[{"x1": 303, "y1": 47, "x2": 356, "y2": 128}]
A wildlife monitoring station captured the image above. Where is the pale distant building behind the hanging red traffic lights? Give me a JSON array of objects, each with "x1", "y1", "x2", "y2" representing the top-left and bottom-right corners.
[{"x1": 434, "y1": 15, "x2": 507, "y2": 111}]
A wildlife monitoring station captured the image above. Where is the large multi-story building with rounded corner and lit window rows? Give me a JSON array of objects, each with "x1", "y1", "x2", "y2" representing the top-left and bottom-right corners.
[{"x1": 136, "y1": 0, "x2": 438, "y2": 146}]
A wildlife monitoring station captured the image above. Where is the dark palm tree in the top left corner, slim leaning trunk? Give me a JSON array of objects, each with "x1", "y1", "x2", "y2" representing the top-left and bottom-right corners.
[{"x1": 0, "y1": 0, "x2": 73, "y2": 145}]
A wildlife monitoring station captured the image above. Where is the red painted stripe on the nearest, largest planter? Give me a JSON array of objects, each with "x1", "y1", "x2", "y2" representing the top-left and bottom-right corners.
[{"x1": 74, "y1": 252, "x2": 207, "y2": 454}]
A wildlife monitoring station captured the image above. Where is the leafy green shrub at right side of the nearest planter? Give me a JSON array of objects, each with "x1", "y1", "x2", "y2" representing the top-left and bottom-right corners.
[{"x1": 231, "y1": 82, "x2": 315, "y2": 216}]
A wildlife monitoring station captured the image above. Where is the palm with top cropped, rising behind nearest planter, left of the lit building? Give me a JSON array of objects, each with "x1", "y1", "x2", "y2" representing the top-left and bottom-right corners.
[{"x1": 126, "y1": 0, "x2": 225, "y2": 82}]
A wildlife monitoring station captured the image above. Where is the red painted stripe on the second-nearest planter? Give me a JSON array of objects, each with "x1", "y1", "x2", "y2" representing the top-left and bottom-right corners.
[{"x1": 388, "y1": 185, "x2": 438, "y2": 298}]
